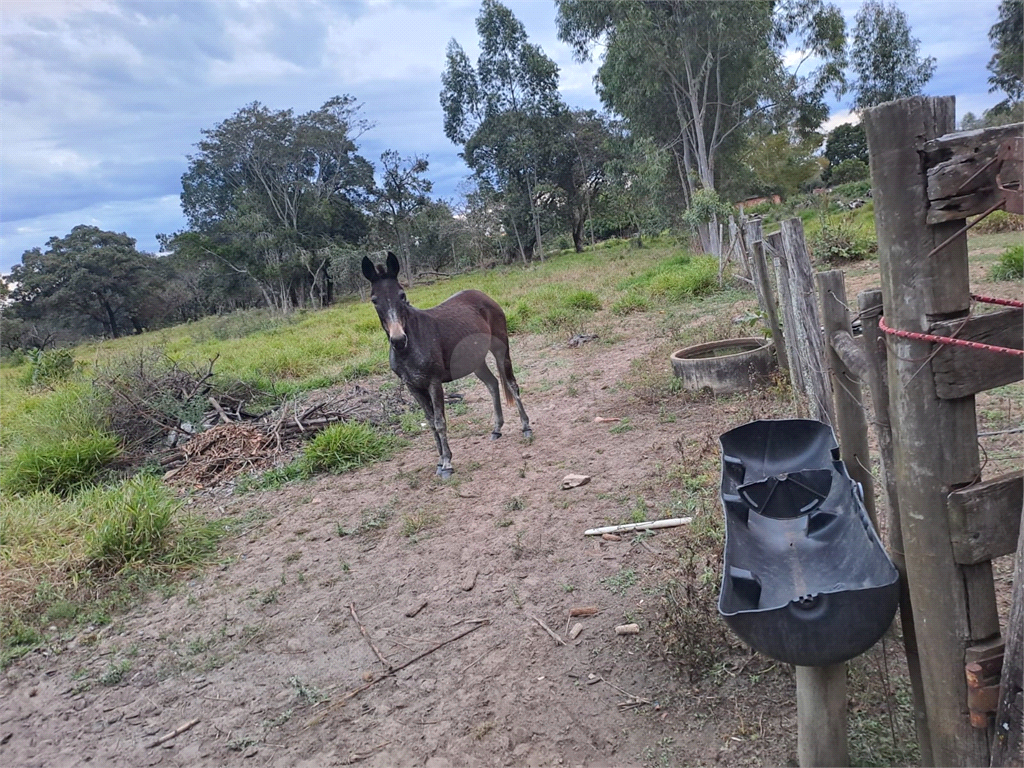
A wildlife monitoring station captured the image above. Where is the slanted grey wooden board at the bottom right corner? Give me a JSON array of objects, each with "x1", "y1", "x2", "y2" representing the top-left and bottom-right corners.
[{"x1": 991, "y1": 495, "x2": 1024, "y2": 766}]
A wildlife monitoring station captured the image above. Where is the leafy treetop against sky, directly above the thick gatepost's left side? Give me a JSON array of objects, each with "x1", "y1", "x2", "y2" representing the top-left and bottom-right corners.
[{"x1": 850, "y1": 0, "x2": 935, "y2": 111}]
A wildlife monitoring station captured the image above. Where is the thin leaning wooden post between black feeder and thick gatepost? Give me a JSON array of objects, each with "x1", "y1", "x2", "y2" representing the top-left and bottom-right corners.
[{"x1": 857, "y1": 288, "x2": 935, "y2": 765}]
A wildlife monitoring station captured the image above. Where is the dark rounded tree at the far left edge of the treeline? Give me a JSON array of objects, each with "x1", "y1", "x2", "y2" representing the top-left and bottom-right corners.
[{"x1": 9, "y1": 224, "x2": 161, "y2": 338}]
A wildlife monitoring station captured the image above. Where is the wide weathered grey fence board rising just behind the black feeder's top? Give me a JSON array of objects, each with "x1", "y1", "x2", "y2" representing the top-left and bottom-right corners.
[{"x1": 781, "y1": 217, "x2": 836, "y2": 425}]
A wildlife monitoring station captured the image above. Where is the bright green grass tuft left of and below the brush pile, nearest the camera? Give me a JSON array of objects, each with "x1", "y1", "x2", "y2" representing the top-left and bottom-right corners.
[{"x1": 79, "y1": 475, "x2": 181, "y2": 570}]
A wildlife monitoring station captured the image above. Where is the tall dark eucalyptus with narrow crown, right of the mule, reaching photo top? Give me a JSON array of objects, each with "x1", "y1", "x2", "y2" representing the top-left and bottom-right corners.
[{"x1": 440, "y1": 0, "x2": 565, "y2": 261}]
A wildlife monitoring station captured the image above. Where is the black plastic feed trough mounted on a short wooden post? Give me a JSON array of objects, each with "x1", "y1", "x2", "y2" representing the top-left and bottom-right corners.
[{"x1": 718, "y1": 419, "x2": 899, "y2": 667}]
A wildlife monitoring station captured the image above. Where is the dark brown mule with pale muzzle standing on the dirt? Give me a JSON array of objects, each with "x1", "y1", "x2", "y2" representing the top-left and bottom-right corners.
[{"x1": 362, "y1": 253, "x2": 534, "y2": 478}]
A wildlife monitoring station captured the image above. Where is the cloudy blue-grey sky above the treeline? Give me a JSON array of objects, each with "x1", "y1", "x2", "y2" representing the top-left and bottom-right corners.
[{"x1": 0, "y1": 0, "x2": 999, "y2": 272}]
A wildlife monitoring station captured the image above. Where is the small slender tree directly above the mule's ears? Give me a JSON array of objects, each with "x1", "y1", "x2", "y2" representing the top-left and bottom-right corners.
[{"x1": 374, "y1": 150, "x2": 433, "y2": 285}]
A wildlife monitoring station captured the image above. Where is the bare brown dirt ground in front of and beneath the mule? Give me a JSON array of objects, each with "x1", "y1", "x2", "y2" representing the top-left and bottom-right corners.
[{"x1": 0, "y1": 268, "x2": 1007, "y2": 768}]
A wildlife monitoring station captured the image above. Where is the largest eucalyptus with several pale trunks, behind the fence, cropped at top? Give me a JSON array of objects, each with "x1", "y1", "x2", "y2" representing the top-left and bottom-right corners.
[{"x1": 556, "y1": 0, "x2": 845, "y2": 259}]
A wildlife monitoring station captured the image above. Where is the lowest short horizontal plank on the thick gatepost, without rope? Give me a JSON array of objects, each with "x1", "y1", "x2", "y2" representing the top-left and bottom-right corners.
[{"x1": 948, "y1": 473, "x2": 1024, "y2": 565}]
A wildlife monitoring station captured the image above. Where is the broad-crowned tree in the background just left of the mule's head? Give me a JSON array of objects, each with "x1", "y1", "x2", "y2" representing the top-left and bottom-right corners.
[{"x1": 181, "y1": 96, "x2": 373, "y2": 311}]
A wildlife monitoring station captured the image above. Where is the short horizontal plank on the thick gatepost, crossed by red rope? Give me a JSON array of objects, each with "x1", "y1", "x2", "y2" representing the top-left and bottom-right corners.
[{"x1": 929, "y1": 308, "x2": 1024, "y2": 399}]
